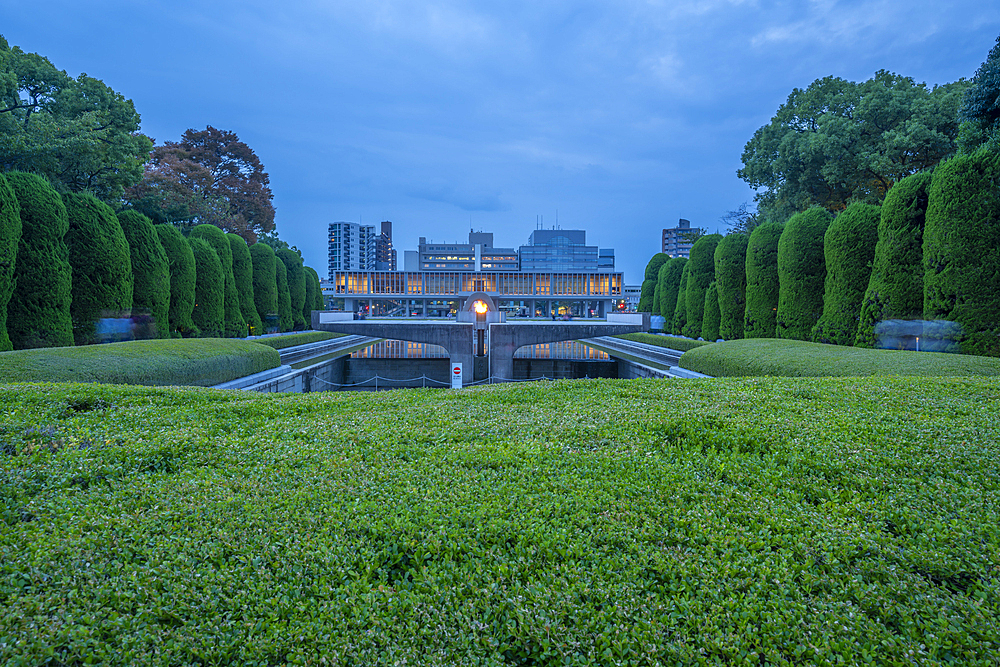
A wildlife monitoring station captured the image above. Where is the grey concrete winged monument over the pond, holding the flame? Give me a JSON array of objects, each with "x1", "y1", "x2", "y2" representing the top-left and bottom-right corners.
[{"x1": 312, "y1": 310, "x2": 648, "y2": 384}]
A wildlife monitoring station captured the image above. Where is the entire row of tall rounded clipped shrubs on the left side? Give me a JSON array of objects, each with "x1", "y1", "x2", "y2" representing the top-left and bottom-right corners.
[{"x1": 0, "y1": 172, "x2": 323, "y2": 350}]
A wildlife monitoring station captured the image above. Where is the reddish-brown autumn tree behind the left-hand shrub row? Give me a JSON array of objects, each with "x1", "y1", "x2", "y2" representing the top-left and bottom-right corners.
[{"x1": 126, "y1": 126, "x2": 274, "y2": 243}]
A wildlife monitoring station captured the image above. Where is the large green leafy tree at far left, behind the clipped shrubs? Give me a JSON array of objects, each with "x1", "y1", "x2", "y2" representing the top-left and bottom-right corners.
[{"x1": 0, "y1": 37, "x2": 152, "y2": 202}]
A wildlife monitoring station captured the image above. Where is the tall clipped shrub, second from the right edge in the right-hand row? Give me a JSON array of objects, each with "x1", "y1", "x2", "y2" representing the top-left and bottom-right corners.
[{"x1": 854, "y1": 172, "x2": 931, "y2": 347}]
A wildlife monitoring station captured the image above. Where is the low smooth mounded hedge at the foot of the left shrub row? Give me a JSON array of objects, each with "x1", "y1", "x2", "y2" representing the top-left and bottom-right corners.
[{"x1": 0, "y1": 338, "x2": 281, "y2": 387}]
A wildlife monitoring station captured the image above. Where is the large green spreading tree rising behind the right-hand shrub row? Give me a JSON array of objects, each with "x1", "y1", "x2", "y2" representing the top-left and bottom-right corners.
[{"x1": 737, "y1": 70, "x2": 968, "y2": 218}]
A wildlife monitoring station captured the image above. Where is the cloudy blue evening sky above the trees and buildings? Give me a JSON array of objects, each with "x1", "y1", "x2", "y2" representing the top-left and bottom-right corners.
[{"x1": 0, "y1": 0, "x2": 1000, "y2": 284}]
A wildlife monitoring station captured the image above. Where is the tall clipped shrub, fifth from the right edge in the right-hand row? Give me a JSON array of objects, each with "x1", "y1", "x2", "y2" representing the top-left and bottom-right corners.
[{"x1": 743, "y1": 222, "x2": 785, "y2": 338}]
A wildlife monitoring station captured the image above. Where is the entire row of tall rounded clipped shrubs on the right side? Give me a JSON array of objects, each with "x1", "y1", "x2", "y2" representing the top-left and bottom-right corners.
[{"x1": 639, "y1": 150, "x2": 1000, "y2": 356}]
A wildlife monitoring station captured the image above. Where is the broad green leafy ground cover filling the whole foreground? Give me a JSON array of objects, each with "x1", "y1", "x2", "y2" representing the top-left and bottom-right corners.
[{"x1": 0, "y1": 378, "x2": 1000, "y2": 667}]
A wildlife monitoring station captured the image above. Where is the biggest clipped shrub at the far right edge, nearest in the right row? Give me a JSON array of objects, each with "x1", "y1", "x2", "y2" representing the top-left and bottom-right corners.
[{"x1": 924, "y1": 148, "x2": 1000, "y2": 357}]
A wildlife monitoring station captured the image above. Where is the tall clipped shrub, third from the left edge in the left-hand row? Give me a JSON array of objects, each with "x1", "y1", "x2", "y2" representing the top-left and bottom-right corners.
[{"x1": 63, "y1": 193, "x2": 133, "y2": 345}]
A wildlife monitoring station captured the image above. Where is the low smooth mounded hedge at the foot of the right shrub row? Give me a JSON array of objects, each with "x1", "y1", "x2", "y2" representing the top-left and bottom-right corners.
[{"x1": 680, "y1": 338, "x2": 1000, "y2": 377}]
